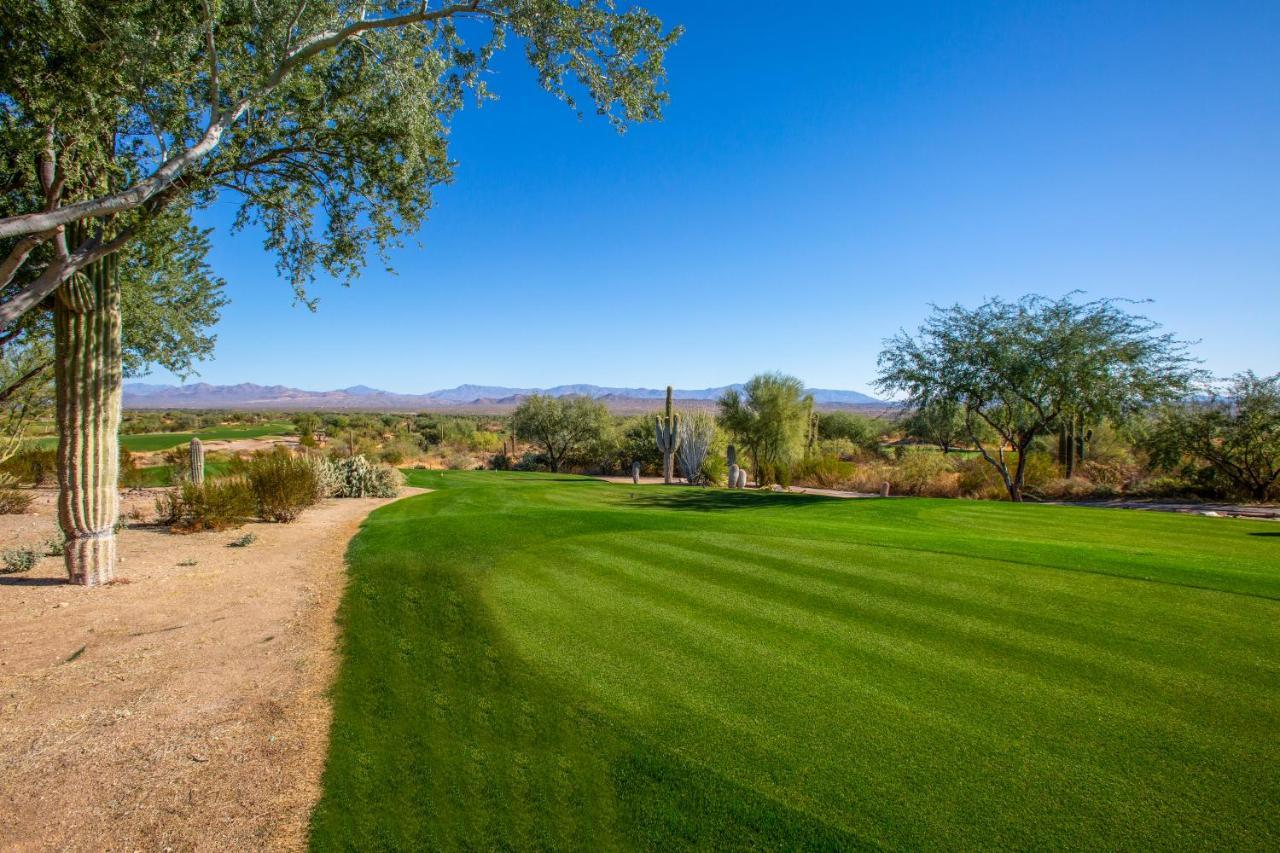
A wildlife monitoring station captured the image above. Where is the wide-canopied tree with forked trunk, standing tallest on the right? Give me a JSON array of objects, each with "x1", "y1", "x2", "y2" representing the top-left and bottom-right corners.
[{"x1": 877, "y1": 293, "x2": 1199, "y2": 501}]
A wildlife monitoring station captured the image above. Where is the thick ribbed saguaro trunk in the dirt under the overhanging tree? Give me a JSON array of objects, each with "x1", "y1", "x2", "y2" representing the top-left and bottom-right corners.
[{"x1": 54, "y1": 235, "x2": 122, "y2": 587}]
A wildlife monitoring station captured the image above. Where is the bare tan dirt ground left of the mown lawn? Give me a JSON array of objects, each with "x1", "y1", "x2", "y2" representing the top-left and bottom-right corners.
[{"x1": 0, "y1": 481, "x2": 420, "y2": 850}]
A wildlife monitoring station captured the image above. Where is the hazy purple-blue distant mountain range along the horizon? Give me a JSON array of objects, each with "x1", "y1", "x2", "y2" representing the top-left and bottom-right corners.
[{"x1": 124, "y1": 382, "x2": 886, "y2": 411}]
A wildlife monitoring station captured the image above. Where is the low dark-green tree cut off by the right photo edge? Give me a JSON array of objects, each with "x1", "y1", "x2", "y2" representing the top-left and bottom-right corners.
[{"x1": 1144, "y1": 371, "x2": 1280, "y2": 501}]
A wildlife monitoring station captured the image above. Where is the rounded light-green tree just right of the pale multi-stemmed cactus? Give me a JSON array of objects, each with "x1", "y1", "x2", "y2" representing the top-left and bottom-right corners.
[{"x1": 717, "y1": 373, "x2": 812, "y2": 485}]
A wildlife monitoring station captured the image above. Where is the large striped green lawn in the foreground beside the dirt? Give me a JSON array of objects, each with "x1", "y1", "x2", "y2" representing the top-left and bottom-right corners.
[{"x1": 312, "y1": 471, "x2": 1280, "y2": 850}]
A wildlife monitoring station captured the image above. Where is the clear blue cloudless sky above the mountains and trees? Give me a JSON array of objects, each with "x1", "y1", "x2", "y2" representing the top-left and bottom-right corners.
[{"x1": 152, "y1": 0, "x2": 1280, "y2": 392}]
